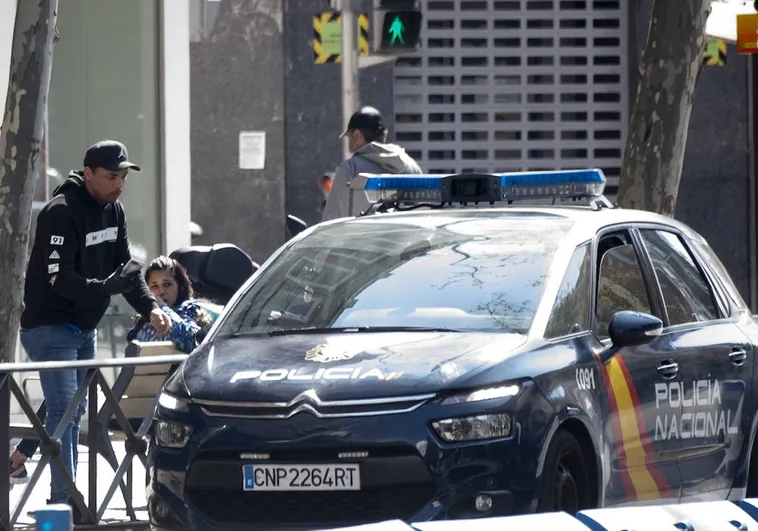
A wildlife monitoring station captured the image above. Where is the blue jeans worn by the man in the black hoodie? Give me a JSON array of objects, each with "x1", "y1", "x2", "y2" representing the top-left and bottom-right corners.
[{"x1": 21, "y1": 326, "x2": 97, "y2": 503}]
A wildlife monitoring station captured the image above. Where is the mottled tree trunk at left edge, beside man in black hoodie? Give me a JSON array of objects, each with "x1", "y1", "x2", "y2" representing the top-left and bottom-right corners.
[{"x1": 0, "y1": 0, "x2": 58, "y2": 362}]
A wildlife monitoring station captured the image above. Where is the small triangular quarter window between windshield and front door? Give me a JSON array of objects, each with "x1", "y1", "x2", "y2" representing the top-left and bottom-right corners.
[{"x1": 545, "y1": 244, "x2": 592, "y2": 339}]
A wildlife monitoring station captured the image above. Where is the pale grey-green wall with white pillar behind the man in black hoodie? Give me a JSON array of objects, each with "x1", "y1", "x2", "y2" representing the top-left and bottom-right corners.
[{"x1": 0, "y1": 0, "x2": 196, "y2": 372}]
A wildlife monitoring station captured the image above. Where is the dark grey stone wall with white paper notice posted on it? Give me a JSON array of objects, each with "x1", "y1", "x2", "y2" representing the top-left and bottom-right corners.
[{"x1": 191, "y1": 0, "x2": 393, "y2": 262}]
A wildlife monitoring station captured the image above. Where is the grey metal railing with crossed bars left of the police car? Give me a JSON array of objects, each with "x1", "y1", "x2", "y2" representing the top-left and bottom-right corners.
[{"x1": 0, "y1": 349, "x2": 187, "y2": 531}]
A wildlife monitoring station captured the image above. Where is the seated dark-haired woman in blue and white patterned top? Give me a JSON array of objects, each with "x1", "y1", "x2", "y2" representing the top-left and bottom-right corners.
[{"x1": 126, "y1": 256, "x2": 222, "y2": 353}]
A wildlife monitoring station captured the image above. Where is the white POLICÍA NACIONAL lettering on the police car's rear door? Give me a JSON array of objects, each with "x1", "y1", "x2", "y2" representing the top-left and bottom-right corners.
[{"x1": 655, "y1": 380, "x2": 741, "y2": 440}]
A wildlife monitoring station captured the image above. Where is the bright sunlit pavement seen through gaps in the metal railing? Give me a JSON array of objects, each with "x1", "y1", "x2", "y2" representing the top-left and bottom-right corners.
[{"x1": 10, "y1": 440, "x2": 147, "y2": 531}]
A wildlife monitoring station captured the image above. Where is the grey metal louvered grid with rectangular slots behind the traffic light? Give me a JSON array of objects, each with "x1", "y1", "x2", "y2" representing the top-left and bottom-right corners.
[{"x1": 395, "y1": 0, "x2": 629, "y2": 193}]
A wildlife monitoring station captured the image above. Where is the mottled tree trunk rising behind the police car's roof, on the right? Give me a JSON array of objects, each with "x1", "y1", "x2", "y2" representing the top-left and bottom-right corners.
[{"x1": 618, "y1": 0, "x2": 711, "y2": 216}]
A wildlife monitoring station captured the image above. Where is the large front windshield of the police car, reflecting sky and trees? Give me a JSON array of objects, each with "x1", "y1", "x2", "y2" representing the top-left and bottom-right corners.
[{"x1": 218, "y1": 212, "x2": 572, "y2": 336}]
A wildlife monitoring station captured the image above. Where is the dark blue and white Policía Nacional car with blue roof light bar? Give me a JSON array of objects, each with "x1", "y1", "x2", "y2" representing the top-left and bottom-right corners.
[{"x1": 148, "y1": 170, "x2": 758, "y2": 530}]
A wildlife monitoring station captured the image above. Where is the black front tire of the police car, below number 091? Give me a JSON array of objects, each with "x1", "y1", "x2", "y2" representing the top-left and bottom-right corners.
[{"x1": 537, "y1": 429, "x2": 593, "y2": 515}]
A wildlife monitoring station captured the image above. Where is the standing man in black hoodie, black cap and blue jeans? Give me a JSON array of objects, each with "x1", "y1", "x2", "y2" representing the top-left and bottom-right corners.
[{"x1": 11, "y1": 140, "x2": 171, "y2": 516}]
